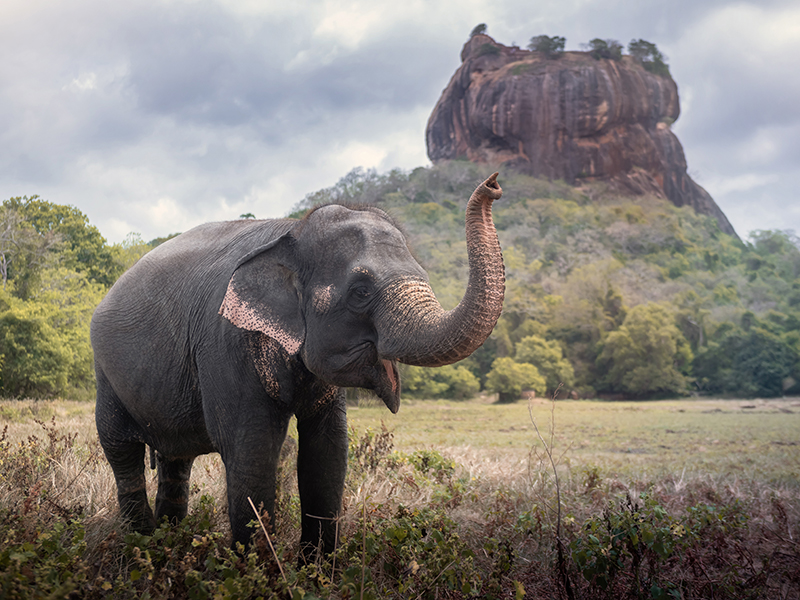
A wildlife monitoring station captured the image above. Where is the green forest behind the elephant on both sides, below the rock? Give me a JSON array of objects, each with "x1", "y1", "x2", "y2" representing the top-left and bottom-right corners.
[{"x1": 0, "y1": 161, "x2": 800, "y2": 401}]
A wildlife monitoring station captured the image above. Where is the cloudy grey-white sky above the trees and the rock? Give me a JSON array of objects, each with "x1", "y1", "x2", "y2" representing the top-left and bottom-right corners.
[{"x1": 0, "y1": 0, "x2": 800, "y2": 242}]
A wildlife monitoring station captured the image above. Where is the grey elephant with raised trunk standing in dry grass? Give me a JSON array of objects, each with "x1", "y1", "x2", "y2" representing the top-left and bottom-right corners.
[{"x1": 91, "y1": 173, "x2": 505, "y2": 556}]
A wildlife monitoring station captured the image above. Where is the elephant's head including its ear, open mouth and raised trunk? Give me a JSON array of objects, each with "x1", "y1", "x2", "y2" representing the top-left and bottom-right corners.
[{"x1": 220, "y1": 173, "x2": 505, "y2": 412}]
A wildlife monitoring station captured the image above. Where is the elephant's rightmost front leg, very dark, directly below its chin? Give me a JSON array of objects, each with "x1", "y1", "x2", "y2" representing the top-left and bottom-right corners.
[{"x1": 297, "y1": 389, "x2": 347, "y2": 560}]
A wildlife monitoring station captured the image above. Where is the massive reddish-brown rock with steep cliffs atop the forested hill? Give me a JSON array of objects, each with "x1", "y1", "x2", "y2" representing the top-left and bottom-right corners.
[{"x1": 426, "y1": 35, "x2": 736, "y2": 235}]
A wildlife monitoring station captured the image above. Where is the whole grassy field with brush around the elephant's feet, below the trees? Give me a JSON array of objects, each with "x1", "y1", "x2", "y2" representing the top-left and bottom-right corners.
[{"x1": 0, "y1": 398, "x2": 800, "y2": 600}]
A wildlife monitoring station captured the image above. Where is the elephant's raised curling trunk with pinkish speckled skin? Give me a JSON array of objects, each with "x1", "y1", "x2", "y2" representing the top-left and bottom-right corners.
[{"x1": 376, "y1": 173, "x2": 505, "y2": 367}]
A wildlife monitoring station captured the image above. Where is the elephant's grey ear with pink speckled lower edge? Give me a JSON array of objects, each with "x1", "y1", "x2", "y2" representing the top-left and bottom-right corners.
[{"x1": 219, "y1": 236, "x2": 305, "y2": 354}]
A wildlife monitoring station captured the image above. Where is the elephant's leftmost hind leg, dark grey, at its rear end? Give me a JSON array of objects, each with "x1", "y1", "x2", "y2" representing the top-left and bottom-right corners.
[{"x1": 95, "y1": 370, "x2": 156, "y2": 533}]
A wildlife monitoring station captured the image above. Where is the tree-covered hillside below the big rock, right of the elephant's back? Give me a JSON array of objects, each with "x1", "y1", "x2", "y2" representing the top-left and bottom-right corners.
[{"x1": 295, "y1": 161, "x2": 800, "y2": 399}]
